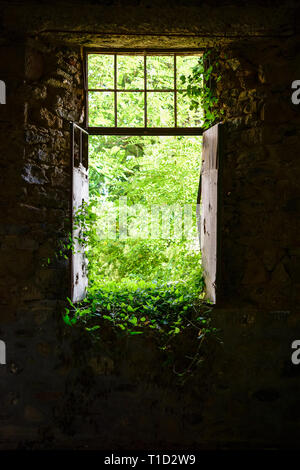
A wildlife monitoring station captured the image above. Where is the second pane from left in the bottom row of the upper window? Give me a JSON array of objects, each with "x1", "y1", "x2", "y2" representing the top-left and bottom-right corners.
[{"x1": 118, "y1": 92, "x2": 144, "y2": 127}]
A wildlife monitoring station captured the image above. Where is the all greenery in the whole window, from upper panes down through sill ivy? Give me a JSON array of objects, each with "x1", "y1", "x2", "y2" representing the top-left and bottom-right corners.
[{"x1": 67, "y1": 52, "x2": 204, "y2": 335}]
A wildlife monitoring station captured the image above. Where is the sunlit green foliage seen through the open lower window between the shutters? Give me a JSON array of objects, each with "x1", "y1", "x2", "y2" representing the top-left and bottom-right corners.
[{"x1": 87, "y1": 136, "x2": 202, "y2": 285}]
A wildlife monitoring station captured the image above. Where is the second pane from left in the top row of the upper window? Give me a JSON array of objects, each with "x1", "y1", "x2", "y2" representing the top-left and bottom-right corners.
[{"x1": 117, "y1": 55, "x2": 144, "y2": 90}]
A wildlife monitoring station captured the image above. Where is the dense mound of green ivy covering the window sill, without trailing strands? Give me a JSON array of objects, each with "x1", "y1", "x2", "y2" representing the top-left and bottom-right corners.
[{"x1": 64, "y1": 280, "x2": 214, "y2": 339}]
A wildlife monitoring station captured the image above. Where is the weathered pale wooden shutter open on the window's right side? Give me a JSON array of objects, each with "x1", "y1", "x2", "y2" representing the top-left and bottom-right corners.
[{"x1": 200, "y1": 124, "x2": 222, "y2": 303}]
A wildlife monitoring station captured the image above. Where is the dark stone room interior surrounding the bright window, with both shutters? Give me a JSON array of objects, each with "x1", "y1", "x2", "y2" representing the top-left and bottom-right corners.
[{"x1": 0, "y1": 0, "x2": 300, "y2": 450}]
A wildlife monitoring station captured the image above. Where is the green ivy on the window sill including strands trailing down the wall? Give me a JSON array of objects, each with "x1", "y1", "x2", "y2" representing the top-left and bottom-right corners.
[{"x1": 64, "y1": 280, "x2": 222, "y2": 383}]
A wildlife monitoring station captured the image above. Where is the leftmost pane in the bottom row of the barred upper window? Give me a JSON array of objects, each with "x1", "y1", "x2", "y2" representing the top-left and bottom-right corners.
[{"x1": 89, "y1": 91, "x2": 115, "y2": 127}]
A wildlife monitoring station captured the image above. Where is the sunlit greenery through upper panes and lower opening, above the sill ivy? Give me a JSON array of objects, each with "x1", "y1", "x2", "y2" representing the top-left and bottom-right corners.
[{"x1": 87, "y1": 52, "x2": 203, "y2": 286}]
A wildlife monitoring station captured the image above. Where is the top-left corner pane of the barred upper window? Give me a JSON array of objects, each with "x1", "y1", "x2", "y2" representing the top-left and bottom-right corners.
[{"x1": 88, "y1": 54, "x2": 114, "y2": 88}]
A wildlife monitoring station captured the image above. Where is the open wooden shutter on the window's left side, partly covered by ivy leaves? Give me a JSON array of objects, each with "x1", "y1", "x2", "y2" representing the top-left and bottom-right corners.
[{"x1": 70, "y1": 122, "x2": 89, "y2": 302}]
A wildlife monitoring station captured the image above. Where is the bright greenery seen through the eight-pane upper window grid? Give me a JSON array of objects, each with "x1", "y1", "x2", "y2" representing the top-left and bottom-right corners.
[{"x1": 87, "y1": 53, "x2": 203, "y2": 128}]
